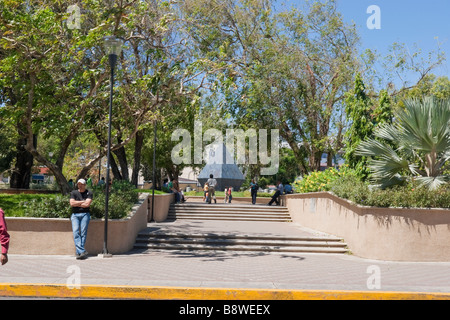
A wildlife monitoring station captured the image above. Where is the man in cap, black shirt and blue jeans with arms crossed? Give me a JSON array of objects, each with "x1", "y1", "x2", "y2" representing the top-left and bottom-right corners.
[{"x1": 70, "y1": 179, "x2": 93, "y2": 259}]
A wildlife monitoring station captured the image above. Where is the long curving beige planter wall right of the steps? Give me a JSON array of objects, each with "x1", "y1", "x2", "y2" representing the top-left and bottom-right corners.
[{"x1": 283, "y1": 192, "x2": 450, "y2": 262}]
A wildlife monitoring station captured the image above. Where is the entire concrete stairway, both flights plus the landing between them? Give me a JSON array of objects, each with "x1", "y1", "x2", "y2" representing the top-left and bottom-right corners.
[{"x1": 134, "y1": 202, "x2": 348, "y2": 253}]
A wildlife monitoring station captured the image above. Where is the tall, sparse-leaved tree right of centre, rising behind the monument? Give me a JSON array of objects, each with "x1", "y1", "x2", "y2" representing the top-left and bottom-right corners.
[{"x1": 181, "y1": 0, "x2": 358, "y2": 173}]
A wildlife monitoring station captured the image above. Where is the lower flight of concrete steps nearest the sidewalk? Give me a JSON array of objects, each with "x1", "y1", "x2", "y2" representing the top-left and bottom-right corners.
[{"x1": 134, "y1": 232, "x2": 348, "y2": 253}]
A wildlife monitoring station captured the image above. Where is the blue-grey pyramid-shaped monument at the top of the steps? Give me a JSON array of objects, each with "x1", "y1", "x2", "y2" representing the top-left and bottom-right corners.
[{"x1": 197, "y1": 143, "x2": 245, "y2": 191}]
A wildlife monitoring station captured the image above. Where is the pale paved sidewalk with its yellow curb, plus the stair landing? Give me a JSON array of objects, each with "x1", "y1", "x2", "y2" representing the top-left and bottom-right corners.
[{"x1": 0, "y1": 220, "x2": 450, "y2": 300}]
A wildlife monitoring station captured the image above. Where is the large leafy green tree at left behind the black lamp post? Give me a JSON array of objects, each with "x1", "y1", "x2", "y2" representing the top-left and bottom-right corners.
[{"x1": 0, "y1": 0, "x2": 229, "y2": 193}]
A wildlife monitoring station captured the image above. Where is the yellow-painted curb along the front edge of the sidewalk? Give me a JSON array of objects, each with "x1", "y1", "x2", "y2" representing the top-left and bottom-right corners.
[{"x1": 0, "y1": 283, "x2": 450, "y2": 300}]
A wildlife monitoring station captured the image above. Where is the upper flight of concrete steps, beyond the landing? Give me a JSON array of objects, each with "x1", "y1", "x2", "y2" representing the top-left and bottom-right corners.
[{"x1": 168, "y1": 202, "x2": 292, "y2": 222}]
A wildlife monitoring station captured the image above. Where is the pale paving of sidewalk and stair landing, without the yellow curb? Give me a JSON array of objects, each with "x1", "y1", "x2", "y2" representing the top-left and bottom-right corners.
[{"x1": 0, "y1": 220, "x2": 450, "y2": 299}]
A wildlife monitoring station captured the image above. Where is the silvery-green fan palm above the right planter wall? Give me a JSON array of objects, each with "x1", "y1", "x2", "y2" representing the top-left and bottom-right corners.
[{"x1": 356, "y1": 97, "x2": 450, "y2": 190}]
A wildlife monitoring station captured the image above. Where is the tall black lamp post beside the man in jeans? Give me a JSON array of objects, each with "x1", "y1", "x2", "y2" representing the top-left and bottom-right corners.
[{"x1": 102, "y1": 36, "x2": 123, "y2": 257}]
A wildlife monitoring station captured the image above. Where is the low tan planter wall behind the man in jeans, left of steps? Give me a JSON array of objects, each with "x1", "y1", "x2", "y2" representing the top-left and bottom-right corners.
[{"x1": 6, "y1": 194, "x2": 148, "y2": 255}]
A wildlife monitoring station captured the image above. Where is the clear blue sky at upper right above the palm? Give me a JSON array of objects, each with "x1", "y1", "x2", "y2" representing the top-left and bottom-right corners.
[{"x1": 286, "y1": 0, "x2": 450, "y2": 87}]
